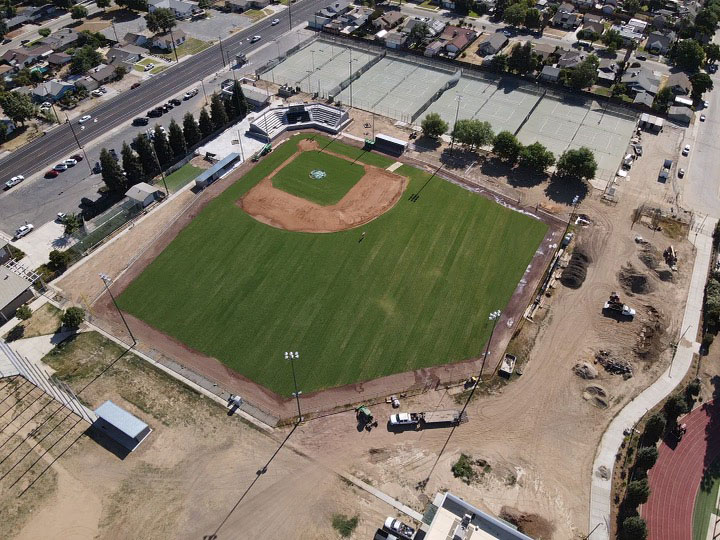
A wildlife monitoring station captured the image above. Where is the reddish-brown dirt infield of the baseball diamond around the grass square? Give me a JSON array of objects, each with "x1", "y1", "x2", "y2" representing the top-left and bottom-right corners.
[{"x1": 238, "y1": 141, "x2": 408, "y2": 232}]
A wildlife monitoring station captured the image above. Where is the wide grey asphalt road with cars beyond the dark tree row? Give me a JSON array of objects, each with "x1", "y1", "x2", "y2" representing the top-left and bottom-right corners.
[{"x1": 0, "y1": 0, "x2": 327, "y2": 182}]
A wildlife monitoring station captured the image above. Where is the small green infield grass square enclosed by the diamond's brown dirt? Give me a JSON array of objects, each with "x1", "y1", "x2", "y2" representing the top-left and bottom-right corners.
[{"x1": 272, "y1": 152, "x2": 365, "y2": 206}]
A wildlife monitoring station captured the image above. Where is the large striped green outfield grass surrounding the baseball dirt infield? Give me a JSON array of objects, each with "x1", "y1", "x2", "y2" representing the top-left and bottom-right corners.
[{"x1": 118, "y1": 136, "x2": 547, "y2": 396}]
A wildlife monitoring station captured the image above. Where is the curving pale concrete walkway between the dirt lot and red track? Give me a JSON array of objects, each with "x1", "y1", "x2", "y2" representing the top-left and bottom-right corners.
[{"x1": 588, "y1": 217, "x2": 717, "y2": 540}]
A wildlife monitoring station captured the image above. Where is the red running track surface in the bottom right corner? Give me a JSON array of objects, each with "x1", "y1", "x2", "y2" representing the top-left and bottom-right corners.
[{"x1": 642, "y1": 402, "x2": 720, "y2": 540}]
